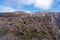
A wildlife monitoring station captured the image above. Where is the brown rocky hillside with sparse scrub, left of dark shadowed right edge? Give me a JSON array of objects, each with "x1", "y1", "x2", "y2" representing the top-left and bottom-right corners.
[{"x1": 0, "y1": 11, "x2": 60, "y2": 40}]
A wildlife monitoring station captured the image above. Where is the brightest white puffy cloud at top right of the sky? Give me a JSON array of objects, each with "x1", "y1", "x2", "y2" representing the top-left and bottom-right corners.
[{"x1": 34, "y1": 0, "x2": 53, "y2": 9}]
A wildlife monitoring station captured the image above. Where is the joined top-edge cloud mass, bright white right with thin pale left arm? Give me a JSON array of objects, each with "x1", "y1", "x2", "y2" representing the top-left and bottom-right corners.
[{"x1": 16, "y1": 0, "x2": 53, "y2": 9}]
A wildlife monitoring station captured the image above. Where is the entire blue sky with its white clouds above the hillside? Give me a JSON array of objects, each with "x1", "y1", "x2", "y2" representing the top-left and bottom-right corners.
[{"x1": 0, "y1": 0, "x2": 60, "y2": 12}]
